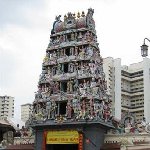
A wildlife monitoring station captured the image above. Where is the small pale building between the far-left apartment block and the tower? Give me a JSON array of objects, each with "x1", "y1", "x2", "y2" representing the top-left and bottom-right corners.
[{"x1": 21, "y1": 103, "x2": 32, "y2": 122}]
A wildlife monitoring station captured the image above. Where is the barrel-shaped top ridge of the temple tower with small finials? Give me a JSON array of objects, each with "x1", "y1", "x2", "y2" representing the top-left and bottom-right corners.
[{"x1": 51, "y1": 8, "x2": 95, "y2": 34}]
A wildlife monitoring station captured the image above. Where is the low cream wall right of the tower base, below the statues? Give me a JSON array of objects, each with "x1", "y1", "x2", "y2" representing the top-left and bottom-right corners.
[{"x1": 104, "y1": 132, "x2": 150, "y2": 150}]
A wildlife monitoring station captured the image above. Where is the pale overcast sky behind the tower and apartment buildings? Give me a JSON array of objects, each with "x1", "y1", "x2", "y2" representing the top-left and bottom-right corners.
[{"x1": 0, "y1": 0, "x2": 150, "y2": 117}]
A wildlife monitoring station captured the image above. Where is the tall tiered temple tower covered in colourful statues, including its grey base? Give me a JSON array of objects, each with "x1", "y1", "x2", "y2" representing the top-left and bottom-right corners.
[{"x1": 31, "y1": 8, "x2": 113, "y2": 150}]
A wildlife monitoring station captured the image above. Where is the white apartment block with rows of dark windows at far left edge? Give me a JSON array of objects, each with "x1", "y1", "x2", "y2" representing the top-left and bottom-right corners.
[{"x1": 0, "y1": 96, "x2": 14, "y2": 119}]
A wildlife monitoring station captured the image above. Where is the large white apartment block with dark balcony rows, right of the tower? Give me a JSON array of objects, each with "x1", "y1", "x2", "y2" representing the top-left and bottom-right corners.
[{"x1": 104, "y1": 57, "x2": 150, "y2": 122}]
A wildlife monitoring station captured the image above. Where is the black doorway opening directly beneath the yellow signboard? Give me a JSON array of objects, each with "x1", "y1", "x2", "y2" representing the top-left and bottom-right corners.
[{"x1": 46, "y1": 144, "x2": 78, "y2": 150}]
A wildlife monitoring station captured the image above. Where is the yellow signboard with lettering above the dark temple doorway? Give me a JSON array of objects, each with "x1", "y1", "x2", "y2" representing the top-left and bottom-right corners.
[{"x1": 46, "y1": 130, "x2": 79, "y2": 144}]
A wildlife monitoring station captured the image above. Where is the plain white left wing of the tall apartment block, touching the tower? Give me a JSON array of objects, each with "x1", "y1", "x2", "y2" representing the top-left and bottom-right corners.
[{"x1": 103, "y1": 57, "x2": 121, "y2": 119}]
